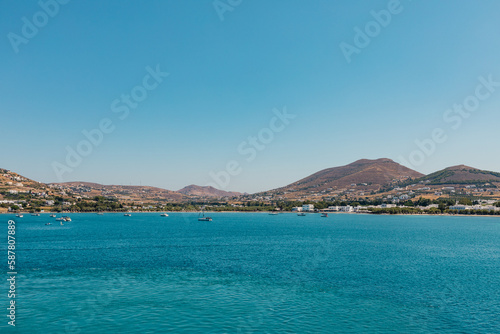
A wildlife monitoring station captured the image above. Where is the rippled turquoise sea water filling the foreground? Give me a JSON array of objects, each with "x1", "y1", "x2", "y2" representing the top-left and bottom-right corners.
[{"x1": 0, "y1": 213, "x2": 500, "y2": 333}]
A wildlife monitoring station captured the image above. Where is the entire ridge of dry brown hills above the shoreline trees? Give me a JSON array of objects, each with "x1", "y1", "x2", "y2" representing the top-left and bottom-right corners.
[{"x1": 0, "y1": 158, "x2": 500, "y2": 202}]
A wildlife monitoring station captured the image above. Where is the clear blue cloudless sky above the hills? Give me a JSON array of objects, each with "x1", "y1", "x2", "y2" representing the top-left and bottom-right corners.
[{"x1": 0, "y1": 0, "x2": 500, "y2": 192}]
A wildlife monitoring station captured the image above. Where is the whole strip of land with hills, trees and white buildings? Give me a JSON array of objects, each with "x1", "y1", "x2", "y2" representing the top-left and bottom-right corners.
[{"x1": 0, "y1": 159, "x2": 500, "y2": 213}]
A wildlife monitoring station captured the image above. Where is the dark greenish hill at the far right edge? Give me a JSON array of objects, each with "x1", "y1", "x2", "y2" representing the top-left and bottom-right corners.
[{"x1": 418, "y1": 165, "x2": 500, "y2": 185}]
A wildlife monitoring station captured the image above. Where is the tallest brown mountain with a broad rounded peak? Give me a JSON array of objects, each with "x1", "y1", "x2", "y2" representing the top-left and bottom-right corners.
[{"x1": 272, "y1": 159, "x2": 424, "y2": 192}]
